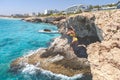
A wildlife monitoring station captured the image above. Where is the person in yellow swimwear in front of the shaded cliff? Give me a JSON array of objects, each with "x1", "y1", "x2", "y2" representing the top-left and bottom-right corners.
[{"x1": 67, "y1": 27, "x2": 78, "y2": 50}]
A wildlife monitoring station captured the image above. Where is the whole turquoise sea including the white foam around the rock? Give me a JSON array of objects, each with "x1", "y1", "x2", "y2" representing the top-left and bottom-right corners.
[{"x1": 0, "y1": 19, "x2": 86, "y2": 80}]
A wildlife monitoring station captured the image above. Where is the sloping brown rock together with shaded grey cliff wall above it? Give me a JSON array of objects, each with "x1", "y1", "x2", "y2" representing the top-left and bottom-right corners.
[{"x1": 11, "y1": 15, "x2": 99, "y2": 76}]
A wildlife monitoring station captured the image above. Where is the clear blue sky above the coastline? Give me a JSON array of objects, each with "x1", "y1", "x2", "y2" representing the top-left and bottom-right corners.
[{"x1": 0, "y1": 0, "x2": 118, "y2": 14}]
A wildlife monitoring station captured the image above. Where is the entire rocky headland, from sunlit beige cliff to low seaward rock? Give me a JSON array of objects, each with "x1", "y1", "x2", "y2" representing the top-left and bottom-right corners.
[{"x1": 10, "y1": 10, "x2": 120, "y2": 80}]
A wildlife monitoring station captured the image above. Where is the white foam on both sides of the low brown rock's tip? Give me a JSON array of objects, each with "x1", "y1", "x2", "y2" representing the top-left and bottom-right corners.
[{"x1": 17, "y1": 48, "x2": 83, "y2": 80}]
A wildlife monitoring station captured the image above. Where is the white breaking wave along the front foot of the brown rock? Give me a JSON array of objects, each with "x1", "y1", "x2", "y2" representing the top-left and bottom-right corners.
[{"x1": 22, "y1": 64, "x2": 83, "y2": 80}]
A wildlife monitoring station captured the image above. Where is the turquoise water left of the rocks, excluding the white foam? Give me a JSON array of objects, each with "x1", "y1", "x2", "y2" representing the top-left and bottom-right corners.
[{"x1": 0, "y1": 19, "x2": 60, "y2": 80}]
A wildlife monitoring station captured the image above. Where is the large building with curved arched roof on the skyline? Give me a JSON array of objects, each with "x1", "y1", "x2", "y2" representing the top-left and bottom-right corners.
[{"x1": 65, "y1": 4, "x2": 88, "y2": 13}]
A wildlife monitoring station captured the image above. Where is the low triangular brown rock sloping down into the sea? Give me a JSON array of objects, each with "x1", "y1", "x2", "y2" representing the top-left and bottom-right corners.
[{"x1": 11, "y1": 37, "x2": 90, "y2": 76}]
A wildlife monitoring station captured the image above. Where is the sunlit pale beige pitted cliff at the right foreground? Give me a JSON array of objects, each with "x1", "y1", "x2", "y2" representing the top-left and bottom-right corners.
[{"x1": 87, "y1": 10, "x2": 120, "y2": 80}]
